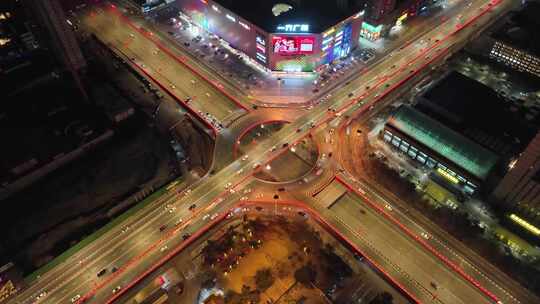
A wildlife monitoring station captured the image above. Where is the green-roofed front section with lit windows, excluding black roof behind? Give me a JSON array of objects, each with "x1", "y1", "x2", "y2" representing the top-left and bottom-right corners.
[{"x1": 382, "y1": 106, "x2": 498, "y2": 194}]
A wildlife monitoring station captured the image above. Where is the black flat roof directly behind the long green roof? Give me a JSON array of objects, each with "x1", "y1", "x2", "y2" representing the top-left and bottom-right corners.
[{"x1": 416, "y1": 71, "x2": 538, "y2": 155}]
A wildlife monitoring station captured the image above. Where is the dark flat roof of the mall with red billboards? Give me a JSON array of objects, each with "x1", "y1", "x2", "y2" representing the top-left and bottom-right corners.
[{"x1": 215, "y1": 0, "x2": 364, "y2": 33}]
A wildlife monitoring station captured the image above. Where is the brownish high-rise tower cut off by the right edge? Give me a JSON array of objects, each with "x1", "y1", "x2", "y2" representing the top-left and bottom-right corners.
[{"x1": 493, "y1": 132, "x2": 540, "y2": 209}]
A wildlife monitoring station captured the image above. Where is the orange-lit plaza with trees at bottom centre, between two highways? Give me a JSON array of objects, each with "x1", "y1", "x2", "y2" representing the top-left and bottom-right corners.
[{"x1": 115, "y1": 204, "x2": 412, "y2": 304}]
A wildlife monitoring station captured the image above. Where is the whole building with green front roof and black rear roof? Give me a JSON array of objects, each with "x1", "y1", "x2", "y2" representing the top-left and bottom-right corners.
[{"x1": 383, "y1": 71, "x2": 538, "y2": 194}]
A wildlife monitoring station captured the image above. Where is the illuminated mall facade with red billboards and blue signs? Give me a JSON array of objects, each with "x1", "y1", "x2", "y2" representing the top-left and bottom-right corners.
[{"x1": 175, "y1": 0, "x2": 362, "y2": 72}]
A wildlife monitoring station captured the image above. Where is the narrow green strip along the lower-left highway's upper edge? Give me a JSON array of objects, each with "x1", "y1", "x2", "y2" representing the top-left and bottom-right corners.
[{"x1": 24, "y1": 181, "x2": 184, "y2": 284}]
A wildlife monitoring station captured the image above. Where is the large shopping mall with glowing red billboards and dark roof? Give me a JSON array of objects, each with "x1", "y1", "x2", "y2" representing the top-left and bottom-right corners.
[{"x1": 174, "y1": 0, "x2": 368, "y2": 72}]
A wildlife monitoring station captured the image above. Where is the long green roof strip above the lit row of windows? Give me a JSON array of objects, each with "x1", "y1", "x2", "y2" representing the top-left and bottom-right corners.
[{"x1": 389, "y1": 106, "x2": 498, "y2": 179}]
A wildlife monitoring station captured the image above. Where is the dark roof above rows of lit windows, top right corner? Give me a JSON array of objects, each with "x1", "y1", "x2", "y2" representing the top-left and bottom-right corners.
[{"x1": 492, "y1": 2, "x2": 540, "y2": 56}]
